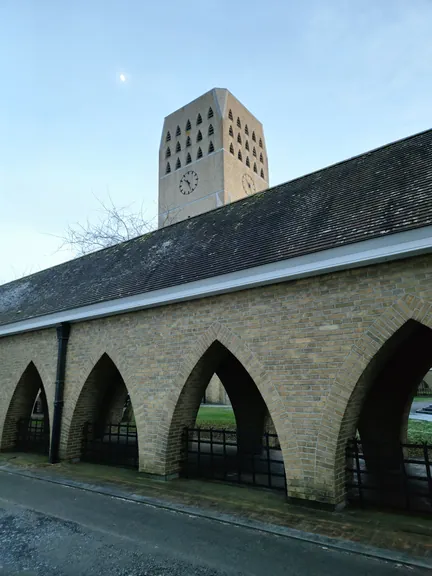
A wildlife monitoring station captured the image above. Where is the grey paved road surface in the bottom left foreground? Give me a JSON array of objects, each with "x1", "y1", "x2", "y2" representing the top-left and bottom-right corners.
[{"x1": 0, "y1": 472, "x2": 424, "y2": 576}]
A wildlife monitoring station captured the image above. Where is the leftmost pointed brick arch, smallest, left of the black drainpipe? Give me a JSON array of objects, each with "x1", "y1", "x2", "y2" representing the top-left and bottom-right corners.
[{"x1": 0, "y1": 360, "x2": 51, "y2": 450}]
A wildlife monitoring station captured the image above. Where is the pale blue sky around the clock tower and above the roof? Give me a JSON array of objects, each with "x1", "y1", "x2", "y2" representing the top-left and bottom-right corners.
[{"x1": 0, "y1": 0, "x2": 432, "y2": 283}]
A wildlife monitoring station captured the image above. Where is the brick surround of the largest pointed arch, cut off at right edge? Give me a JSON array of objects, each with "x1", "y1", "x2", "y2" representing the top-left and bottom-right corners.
[{"x1": 315, "y1": 294, "x2": 432, "y2": 504}]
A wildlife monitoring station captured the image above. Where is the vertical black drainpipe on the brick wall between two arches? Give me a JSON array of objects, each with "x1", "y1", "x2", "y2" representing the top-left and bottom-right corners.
[{"x1": 49, "y1": 322, "x2": 70, "y2": 464}]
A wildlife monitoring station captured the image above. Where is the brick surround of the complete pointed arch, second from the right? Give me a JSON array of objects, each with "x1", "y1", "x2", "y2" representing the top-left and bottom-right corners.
[{"x1": 157, "y1": 322, "x2": 303, "y2": 488}]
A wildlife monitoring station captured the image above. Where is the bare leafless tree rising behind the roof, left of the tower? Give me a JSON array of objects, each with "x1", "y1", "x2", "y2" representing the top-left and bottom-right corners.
[{"x1": 61, "y1": 196, "x2": 177, "y2": 256}]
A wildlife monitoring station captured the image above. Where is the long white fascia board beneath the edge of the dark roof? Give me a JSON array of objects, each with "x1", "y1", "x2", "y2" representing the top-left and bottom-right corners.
[{"x1": 0, "y1": 226, "x2": 432, "y2": 337}]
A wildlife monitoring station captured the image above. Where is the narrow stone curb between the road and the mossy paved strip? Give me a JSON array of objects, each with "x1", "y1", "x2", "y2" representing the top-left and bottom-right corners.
[{"x1": 0, "y1": 464, "x2": 432, "y2": 570}]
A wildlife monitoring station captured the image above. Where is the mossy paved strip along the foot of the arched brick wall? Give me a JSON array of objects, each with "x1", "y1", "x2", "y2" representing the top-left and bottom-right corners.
[{"x1": 0, "y1": 453, "x2": 432, "y2": 566}]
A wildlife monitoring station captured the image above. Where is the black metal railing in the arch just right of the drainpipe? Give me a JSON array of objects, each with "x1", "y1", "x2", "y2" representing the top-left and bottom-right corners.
[{"x1": 81, "y1": 422, "x2": 138, "y2": 468}]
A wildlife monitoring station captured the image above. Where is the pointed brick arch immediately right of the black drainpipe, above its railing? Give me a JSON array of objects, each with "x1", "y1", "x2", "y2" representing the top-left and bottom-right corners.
[{"x1": 61, "y1": 351, "x2": 140, "y2": 459}]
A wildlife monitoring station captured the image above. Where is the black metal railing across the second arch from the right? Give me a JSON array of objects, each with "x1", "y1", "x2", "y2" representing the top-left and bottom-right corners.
[{"x1": 181, "y1": 428, "x2": 286, "y2": 493}]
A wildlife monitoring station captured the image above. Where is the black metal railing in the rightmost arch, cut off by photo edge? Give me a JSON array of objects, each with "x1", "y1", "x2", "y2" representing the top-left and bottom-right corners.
[{"x1": 346, "y1": 438, "x2": 432, "y2": 514}]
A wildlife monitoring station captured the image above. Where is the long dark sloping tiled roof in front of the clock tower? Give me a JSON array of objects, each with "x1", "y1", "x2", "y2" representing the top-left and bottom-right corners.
[{"x1": 0, "y1": 130, "x2": 432, "y2": 325}]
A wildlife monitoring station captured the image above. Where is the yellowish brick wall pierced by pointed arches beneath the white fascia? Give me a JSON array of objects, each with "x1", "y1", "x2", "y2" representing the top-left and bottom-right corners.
[{"x1": 0, "y1": 256, "x2": 432, "y2": 504}]
